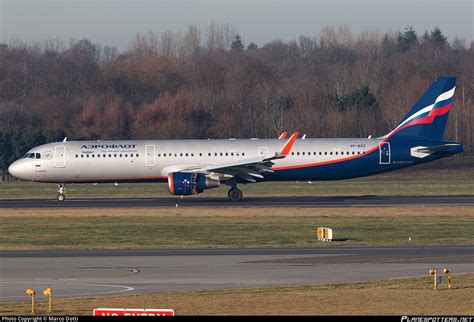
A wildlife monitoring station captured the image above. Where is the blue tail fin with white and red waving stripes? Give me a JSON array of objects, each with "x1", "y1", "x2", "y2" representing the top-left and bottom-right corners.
[{"x1": 384, "y1": 77, "x2": 456, "y2": 141}]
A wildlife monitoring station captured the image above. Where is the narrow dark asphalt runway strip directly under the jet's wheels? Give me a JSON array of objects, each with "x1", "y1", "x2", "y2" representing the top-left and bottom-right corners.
[{"x1": 0, "y1": 195, "x2": 474, "y2": 208}]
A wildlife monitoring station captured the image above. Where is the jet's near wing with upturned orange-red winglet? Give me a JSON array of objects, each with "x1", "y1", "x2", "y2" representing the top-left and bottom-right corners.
[{"x1": 181, "y1": 132, "x2": 298, "y2": 182}]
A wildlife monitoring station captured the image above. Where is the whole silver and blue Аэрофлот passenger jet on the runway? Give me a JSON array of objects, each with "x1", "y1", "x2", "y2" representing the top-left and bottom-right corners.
[{"x1": 8, "y1": 77, "x2": 463, "y2": 201}]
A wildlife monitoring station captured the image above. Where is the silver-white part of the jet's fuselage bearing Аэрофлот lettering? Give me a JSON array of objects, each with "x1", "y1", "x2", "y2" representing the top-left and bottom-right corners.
[{"x1": 9, "y1": 138, "x2": 380, "y2": 183}]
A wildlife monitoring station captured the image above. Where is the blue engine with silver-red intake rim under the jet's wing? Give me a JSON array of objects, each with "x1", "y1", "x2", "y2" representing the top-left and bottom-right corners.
[{"x1": 168, "y1": 172, "x2": 220, "y2": 196}]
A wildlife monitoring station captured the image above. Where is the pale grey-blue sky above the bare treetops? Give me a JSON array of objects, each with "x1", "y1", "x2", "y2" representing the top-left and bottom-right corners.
[{"x1": 0, "y1": 0, "x2": 474, "y2": 50}]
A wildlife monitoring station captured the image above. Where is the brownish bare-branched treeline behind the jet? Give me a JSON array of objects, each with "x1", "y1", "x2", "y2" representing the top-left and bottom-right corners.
[{"x1": 0, "y1": 23, "x2": 474, "y2": 169}]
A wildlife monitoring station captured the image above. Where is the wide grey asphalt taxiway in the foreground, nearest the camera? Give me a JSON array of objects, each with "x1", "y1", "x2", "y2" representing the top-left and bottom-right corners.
[{"x1": 0, "y1": 246, "x2": 474, "y2": 302}]
